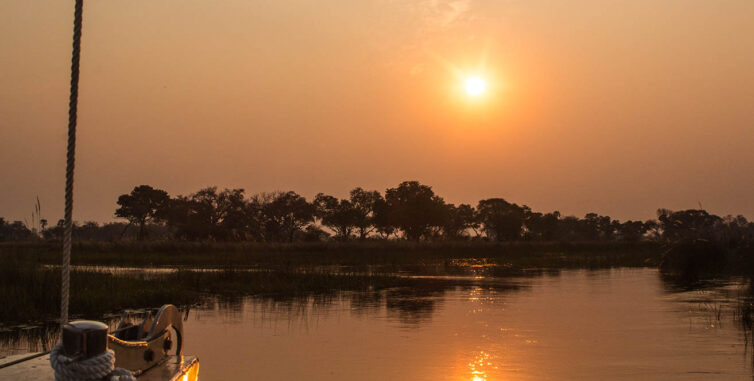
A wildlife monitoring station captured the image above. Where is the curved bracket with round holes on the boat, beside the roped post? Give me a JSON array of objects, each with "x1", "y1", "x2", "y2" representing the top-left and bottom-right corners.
[{"x1": 108, "y1": 304, "x2": 183, "y2": 375}]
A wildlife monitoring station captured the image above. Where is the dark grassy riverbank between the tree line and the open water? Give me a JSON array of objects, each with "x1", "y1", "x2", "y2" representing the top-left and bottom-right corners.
[{"x1": 0, "y1": 241, "x2": 663, "y2": 323}]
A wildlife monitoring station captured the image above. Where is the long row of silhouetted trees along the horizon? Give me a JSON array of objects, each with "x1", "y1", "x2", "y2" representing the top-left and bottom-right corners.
[{"x1": 0, "y1": 181, "x2": 754, "y2": 242}]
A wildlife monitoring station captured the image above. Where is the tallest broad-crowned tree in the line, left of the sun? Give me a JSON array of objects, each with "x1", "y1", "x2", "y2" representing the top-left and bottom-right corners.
[{"x1": 385, "y1": 181, "x2": 445, "y2": 240}]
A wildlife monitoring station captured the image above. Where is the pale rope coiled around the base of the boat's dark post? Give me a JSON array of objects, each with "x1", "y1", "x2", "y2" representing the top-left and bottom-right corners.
[{"x1": 50, "y1": 344, "x2": 136, "y2": 381}]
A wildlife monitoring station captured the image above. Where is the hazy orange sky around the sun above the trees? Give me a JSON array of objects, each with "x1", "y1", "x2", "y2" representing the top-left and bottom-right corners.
[{"x1": 0, "y1": 0, "x2": 754, "y2": 221}]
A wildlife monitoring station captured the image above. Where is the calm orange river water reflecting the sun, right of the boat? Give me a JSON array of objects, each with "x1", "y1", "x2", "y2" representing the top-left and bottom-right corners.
[{"x1": 4, "y1": 269, "x2": 752, "y2": 381}]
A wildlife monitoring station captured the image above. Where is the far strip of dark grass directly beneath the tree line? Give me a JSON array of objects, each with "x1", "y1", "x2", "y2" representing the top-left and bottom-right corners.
[{"x1": 0, "y1": 241, "x2": 663, "y2": 270}]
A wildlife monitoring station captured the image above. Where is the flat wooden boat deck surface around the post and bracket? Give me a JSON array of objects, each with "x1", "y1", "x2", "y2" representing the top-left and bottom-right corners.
[{"x1": 0, "y1": 352, "x2": 199, "y2": 381}]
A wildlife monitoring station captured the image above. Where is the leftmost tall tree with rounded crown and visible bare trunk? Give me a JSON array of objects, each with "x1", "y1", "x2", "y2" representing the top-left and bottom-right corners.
[{"x1": 115, "y1": 185, "x2": 170, "y2": 240}]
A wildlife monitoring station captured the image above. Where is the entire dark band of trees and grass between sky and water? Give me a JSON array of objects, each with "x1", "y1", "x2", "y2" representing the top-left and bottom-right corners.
[{"x1": 0, "y1": 181, "x2": 754, "y2": 322}]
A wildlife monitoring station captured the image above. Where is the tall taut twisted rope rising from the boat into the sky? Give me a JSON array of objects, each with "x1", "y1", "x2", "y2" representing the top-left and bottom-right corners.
[{"x1": 60, "y1": 0, "x2": 84, "y2": 325}]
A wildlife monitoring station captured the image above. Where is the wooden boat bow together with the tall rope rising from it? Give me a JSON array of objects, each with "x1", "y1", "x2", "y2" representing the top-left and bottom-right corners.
[{"x1": 0, "y1": 0, "x2": 199, "y2": 381}]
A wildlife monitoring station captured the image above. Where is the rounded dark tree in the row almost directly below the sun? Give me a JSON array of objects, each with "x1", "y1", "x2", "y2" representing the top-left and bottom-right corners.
[{"x1": 477, "y1": 198, "x2": 528, "y2": 241}]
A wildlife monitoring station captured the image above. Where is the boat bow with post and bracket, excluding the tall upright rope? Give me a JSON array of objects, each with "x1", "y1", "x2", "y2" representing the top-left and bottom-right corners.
[{"x1": 0, "y1": 304, "x2": 199, "y2": 381}]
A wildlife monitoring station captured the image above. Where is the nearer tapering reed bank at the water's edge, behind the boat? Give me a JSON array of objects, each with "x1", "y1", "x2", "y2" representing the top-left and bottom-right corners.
[{"x1": 0, "y1": 254, "x2": 520, "y2": 326}]
